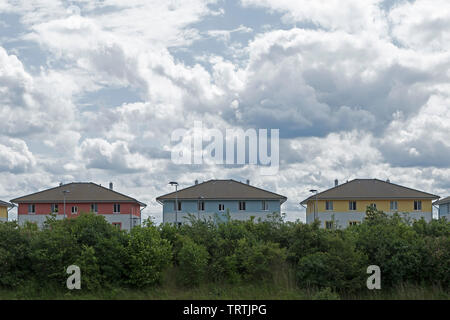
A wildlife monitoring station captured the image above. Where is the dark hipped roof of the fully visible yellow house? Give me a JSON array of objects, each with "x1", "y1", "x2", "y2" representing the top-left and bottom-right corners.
[{"x1": 301, "y1": 179, "x2": 439, "y2": 204}]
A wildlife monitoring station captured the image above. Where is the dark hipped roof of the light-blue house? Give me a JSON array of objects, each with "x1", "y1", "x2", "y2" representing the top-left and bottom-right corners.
[{"x1": 156, "y1": 180, "x2": 287, "y2": 203}]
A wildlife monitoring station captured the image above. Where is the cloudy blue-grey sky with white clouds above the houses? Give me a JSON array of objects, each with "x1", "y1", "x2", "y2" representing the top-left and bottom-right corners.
[{"x1": 0, "y1": 0, "x2": 450, "y2": 221}]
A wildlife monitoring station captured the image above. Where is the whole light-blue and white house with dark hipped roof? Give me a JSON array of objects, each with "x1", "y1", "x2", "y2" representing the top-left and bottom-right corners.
[{"x1": 156, "y1": 180, "x2": 287, "y2": 224}]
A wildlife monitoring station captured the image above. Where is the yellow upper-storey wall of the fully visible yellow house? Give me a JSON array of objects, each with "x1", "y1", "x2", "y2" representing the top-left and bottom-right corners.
[{"x1": 306, "y1": 199, "x2": 433, "y2": 213}]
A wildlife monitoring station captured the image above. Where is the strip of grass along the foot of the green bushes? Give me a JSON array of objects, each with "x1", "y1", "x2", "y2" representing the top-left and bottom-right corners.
[{"x1": 0, "y1": 284, "x2": 450, "y2": 300}]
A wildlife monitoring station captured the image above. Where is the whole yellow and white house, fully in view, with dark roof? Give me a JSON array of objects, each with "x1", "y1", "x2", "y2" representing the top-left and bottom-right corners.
[{"x1": 301, "y1": 179, "x2": 439, "y2": 228}]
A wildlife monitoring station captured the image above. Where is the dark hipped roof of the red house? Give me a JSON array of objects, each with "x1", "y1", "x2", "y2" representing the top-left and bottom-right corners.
[{"x1": 11, "y1": 182, "x2": 146, "y2": 206}]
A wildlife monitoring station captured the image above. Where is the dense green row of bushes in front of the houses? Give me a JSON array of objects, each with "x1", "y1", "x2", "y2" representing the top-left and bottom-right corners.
[{"x1": 0, "y1": 209, "x2": 450, "y2": 298}]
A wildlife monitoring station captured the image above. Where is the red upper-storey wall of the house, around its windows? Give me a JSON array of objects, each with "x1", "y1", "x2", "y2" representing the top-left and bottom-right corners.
[{"x1": 17, "y1": 202, "x2": 141, "y2": 217}]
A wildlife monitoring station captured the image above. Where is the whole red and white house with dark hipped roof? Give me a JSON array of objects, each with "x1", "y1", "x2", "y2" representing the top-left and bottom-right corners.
[{"x1": 11, "y1": 182, "x2": 146, "y2": 230}]
